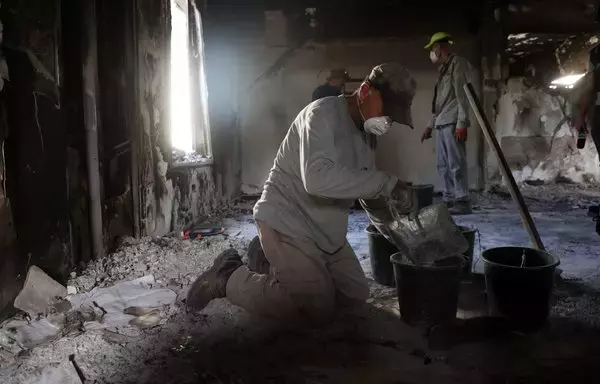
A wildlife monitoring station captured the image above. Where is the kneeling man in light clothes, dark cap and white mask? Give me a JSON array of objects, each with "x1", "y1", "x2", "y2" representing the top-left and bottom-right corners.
[{"x1": 187, "y1": 63, "x2": 416, "y2": 323}]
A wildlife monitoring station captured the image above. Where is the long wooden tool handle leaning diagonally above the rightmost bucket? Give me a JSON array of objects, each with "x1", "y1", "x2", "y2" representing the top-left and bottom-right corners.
[{"x1": 464, "y1": 83, "x2": 545, "y2": 251}]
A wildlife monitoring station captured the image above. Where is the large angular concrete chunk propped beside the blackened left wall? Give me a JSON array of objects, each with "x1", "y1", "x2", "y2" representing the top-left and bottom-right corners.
[{"x1": 14, "y1": 265, "x2": 67, "y2": 317}]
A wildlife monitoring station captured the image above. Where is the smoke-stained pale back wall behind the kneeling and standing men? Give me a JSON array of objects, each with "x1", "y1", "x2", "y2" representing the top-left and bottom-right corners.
[{"x1": 235, "y1": 35, "x2": 482, "y2": 193}]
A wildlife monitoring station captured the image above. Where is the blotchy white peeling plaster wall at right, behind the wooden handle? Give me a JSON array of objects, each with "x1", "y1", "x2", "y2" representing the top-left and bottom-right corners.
[{"x1": 486, "y1": 78, "x2": 600, "y2": 183}]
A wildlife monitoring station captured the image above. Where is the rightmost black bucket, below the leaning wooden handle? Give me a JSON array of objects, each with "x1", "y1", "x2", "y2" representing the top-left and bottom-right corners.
[{"x1": 482, "y1": 247, "x2": 560, "y2": 332}]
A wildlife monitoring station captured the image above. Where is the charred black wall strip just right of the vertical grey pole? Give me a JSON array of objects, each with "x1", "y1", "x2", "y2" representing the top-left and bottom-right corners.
[{"x1": 97, "y1": 0, "x2": 137, "y2": 249}]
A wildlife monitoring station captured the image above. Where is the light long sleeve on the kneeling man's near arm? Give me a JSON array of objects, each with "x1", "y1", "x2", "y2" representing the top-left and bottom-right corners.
[{"x1": 298, "y1": 110, "x2": 398, "y2": 200}]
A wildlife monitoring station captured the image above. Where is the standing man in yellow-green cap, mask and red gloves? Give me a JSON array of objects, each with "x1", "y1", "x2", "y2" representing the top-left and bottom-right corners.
[{"x1": 421, "y1": 32, "x2": 472, "y2": 215}]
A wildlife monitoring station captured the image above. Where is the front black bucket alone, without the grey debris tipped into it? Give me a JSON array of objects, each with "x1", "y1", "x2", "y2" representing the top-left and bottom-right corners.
[{"x1": 391, "y1": 253, "x2": 463, "y2": 327}]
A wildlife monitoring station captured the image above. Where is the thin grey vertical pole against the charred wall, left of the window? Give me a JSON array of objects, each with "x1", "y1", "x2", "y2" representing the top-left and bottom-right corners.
[{"x1": 80, "y1": 0, "x2": 104, "y2": 259}]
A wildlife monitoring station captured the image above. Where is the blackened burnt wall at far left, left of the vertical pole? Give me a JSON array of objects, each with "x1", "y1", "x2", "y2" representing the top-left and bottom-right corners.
[{"x1": 0, "y1": 0, "x2": 73, "y2": 314}]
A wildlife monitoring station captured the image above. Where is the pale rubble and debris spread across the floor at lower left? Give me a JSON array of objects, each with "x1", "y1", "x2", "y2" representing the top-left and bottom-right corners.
[{"x1": 0, "y1": 235, "x2": 253, "y2": 383}]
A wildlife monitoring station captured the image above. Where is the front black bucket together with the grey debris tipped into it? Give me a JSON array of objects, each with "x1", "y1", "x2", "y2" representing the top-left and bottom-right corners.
[{"x1": 384, "y1": 204, "x2": 469, "y2": 327}]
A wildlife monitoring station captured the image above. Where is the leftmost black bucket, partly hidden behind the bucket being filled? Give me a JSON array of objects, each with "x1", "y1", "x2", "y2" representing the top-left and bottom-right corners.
[{"x1": 365, "y1": 225, "x2": 398, "y2": 287}]
